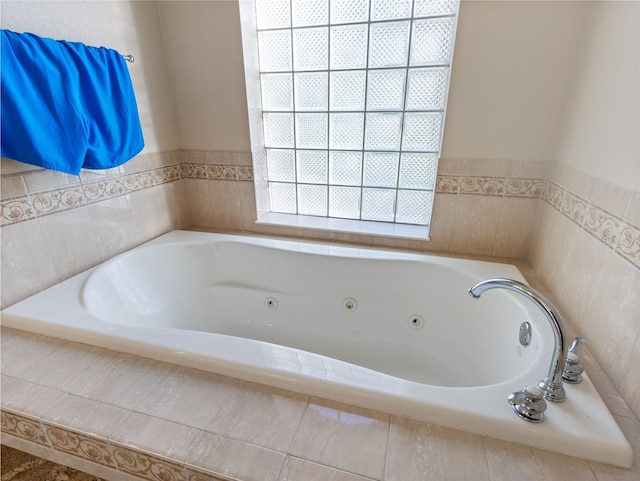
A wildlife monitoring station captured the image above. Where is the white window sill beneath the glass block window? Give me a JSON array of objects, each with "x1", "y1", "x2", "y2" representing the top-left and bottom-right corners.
[{"x1": 256, "y1": 212, "x2": 429, "y2": 241}]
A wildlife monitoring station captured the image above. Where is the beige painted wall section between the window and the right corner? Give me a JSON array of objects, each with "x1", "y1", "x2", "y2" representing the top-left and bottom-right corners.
[{"x1": 442, "y1": 1, "x2": 585, "y2": 161}]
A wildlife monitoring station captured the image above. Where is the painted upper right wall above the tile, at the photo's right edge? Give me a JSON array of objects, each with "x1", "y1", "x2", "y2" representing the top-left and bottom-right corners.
[{"x1": 554, "y1": 1, "x2": 640, "y2": 191}]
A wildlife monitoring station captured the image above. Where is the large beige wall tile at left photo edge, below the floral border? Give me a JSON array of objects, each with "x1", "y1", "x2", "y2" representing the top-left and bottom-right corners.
[{"x1": 0, "y1": 221, "x2": 58, "y2": 308}]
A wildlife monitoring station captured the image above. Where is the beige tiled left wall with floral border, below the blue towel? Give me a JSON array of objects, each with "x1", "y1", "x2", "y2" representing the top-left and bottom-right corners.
[{"x1": 0, "y1": 152, "x2": 186, "y2": 307}]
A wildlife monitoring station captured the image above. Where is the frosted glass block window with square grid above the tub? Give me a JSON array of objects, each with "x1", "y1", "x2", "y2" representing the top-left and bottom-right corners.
[{"x1": 246, "y1": 0, "x2": 459, "y2": 226}]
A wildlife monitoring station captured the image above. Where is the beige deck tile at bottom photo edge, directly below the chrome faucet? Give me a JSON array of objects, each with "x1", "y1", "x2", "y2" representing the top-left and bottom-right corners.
[{"x1": 484, "y1": 438, "x2": 597, "y2": 481}]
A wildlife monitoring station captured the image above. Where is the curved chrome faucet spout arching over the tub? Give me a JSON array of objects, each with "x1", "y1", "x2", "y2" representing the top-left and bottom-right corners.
[{"x1": 469, "y1": 279, "x2": 567, "y2": 402}]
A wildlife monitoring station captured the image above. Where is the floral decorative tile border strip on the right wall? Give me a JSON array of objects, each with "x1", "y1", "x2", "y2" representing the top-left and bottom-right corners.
[{"x1": 543, "y1": 180, "x2": 640, "y2": 269}]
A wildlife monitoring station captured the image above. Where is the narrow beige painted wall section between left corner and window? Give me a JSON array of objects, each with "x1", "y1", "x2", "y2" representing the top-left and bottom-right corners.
[{"x1": 158, "y1": 0, "x2": 251, "y2": 151}]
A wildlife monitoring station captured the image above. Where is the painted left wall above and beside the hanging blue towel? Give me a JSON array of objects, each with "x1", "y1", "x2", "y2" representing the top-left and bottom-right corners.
[{"x1": 0, "y1": 0, "x2": 180, "y2": 154}]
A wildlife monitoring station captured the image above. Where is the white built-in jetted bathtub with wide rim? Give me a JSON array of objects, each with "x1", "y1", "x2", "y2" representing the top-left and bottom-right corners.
[{"x1": 2, "y1": 231, "x2": 632, "y2": 467}]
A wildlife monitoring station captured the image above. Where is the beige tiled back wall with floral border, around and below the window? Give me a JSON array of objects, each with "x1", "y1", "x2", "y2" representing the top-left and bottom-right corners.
[{"x1": 183, "y1": 151, "x2": 548, "y2": 258}]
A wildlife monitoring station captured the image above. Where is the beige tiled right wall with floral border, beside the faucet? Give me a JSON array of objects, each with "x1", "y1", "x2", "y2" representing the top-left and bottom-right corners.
[{"x1": 529, "y1": 164, "x2": 640, "y2": 416}]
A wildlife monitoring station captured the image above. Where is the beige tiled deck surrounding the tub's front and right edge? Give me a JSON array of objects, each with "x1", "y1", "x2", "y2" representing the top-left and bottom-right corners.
[{"x1": 1, "y1": 264, "x2": 640, "y2": 481}]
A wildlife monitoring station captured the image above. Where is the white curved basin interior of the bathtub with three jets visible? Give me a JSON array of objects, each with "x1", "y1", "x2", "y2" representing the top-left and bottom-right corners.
[{"x1": 82, "y1": 241, "x2": 546, "y2": 387}]
